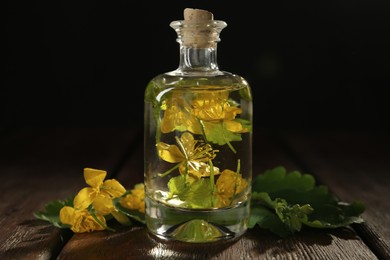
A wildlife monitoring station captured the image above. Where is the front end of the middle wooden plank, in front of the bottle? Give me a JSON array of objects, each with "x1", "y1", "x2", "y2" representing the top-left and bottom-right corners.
[{"x1": 58, "y1": 224, "x2": 377, "y2": 260}]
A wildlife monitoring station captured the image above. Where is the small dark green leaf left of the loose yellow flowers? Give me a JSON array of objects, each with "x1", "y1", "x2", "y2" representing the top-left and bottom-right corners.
[{"x1": 34, "y1": 197, "x2": 73, "y2": 228}]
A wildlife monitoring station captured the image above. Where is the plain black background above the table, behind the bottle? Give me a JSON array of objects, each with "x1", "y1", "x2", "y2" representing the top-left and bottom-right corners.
[{"x1": 0, "y1": 0, "x2": 390, "y2": 130}]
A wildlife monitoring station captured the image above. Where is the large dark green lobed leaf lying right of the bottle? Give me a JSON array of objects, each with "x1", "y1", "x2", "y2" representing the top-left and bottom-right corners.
[{"x1": 251, "y1": 166, "x2": 365, "y2": 237}]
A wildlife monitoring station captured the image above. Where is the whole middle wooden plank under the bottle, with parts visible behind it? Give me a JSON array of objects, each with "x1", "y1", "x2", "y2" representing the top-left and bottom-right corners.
[{"x1": 58, "y1": 133, "x2": 377, "y2": 260}]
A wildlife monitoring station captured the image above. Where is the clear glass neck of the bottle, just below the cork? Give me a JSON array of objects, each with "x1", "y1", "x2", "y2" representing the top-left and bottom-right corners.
[{"x1": 178, "y1": 44, "x2": 218, "y2": 72}]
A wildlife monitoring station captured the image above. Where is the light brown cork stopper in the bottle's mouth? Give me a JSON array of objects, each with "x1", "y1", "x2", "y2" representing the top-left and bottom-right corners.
[{"x1": 181, "y1": 8, "x2": 226, "y2": 48}]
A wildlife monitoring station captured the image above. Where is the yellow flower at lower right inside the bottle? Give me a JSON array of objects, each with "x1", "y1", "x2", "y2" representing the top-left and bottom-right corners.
[{"x1": 216, "y1": 169, "x2": 248, "y2": 207}]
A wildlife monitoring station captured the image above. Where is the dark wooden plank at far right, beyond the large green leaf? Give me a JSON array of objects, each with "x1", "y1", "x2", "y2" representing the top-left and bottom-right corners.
[{"x1": 285, "y1": 132, "x2": 390, "y2": 259}]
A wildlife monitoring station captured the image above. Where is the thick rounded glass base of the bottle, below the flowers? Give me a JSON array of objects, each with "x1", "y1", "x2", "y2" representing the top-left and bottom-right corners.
[{"x1": 146, "y1": 198, "x2": 249, "y2": 243}]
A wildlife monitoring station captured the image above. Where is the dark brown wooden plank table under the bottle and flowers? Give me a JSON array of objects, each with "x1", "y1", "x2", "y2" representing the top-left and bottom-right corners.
[{"x1": 0, "y1": 128, "x2": 390, "y2": 260}]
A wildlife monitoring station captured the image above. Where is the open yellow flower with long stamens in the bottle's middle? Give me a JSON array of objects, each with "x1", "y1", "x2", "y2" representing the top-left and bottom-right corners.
[{"x1": 156, "y1": 132, "x2": 219, "y2": 179}]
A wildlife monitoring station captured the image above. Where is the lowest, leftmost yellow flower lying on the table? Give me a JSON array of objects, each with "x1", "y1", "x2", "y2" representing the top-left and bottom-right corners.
[{"x1": 60, "y1": 206, "x2": 106, "y2": 233}]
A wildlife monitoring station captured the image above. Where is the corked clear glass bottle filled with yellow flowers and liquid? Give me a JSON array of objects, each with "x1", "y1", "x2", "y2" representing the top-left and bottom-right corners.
[{"x1": 144, "y1": 8, "x2": 252, "y2": 243}]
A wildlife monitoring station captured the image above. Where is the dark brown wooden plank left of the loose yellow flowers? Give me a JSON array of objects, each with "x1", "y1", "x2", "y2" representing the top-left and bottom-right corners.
[{"x1": 0, "y1": 128, "x2": 137, "y2": 259}]
